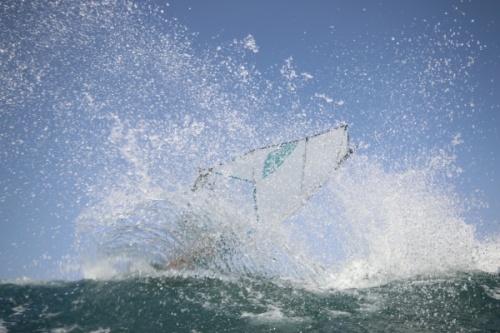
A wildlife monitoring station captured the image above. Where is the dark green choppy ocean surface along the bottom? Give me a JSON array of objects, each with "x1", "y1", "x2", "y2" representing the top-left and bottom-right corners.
[{"x1": 0, "y1": 272, "x2": 500, "y2": 332}]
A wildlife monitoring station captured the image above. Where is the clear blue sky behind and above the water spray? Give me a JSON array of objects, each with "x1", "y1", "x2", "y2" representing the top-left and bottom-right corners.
[{"x1": 0, "y1": 0, "x2": 500, "y2": 279}]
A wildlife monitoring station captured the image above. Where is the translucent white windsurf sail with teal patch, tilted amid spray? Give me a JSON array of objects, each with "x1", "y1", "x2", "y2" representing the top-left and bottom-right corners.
[{"x1": 193, "y1": 125, "x2": 353, "y2": 222}]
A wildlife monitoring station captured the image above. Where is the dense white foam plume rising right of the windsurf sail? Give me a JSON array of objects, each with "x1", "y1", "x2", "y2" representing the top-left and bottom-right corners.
[{"x1": 290, "y1": 154, "x2": 500, "y2": 289}]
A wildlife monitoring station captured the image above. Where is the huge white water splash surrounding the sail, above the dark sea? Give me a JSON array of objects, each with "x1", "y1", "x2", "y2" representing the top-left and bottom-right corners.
[{"x1": 0, "y1": 0, "x2": 499, "y2": 287}]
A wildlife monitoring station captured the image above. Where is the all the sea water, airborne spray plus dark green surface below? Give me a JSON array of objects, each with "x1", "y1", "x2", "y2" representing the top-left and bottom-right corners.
[{"x1": 0, "y1": 0, "x2": 500, "y2": 332}]
